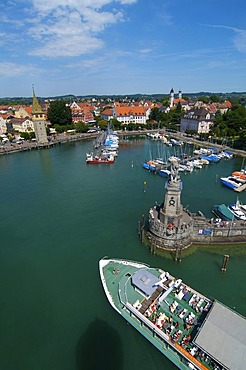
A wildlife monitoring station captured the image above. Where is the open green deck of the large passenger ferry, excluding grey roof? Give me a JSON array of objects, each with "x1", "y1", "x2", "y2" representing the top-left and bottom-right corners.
[{"x1": 103, "y1": 263, "x2": 227, "y2": 370}]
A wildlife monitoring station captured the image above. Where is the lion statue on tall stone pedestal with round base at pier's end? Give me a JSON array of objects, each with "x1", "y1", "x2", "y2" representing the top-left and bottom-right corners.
[{"x1": 147, "y1": 157, "x2": 193, "y2": 252}]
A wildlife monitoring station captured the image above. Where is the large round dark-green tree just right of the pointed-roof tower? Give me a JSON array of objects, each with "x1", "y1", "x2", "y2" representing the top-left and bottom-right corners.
[{"x1": 47, "y1": 100, "x2": 72, "y2": 126}]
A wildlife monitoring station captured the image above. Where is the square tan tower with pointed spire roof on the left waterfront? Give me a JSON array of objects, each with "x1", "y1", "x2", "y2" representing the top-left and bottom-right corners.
[{"x1": 32, "y1": 88, "x2": 48, "y2": 145}]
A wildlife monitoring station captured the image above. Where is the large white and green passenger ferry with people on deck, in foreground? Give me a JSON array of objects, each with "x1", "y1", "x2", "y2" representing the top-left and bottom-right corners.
[{"x1": 99, "y1": 258, "x2": 246, "y2": 370}]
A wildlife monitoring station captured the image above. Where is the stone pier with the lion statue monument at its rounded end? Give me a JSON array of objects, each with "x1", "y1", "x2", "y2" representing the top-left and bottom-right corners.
[{"x1": 145, "y1": 157, "x2": 246, "y2": 256}]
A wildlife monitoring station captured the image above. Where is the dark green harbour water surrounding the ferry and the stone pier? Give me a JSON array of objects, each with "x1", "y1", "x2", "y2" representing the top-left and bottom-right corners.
[{"x1": 0, "y1": 140, "x2": 246, "y2": 370}]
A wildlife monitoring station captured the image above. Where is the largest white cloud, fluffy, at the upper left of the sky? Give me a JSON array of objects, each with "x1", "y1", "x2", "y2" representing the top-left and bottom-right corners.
[{"x1": 25, "y1": 0, "x2": 131, "y2": 58}]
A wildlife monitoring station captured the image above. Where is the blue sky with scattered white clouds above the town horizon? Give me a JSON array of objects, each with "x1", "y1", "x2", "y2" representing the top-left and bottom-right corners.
[{"x1": 0, "y1": 0, "x2": 246, "y2": 97}]
